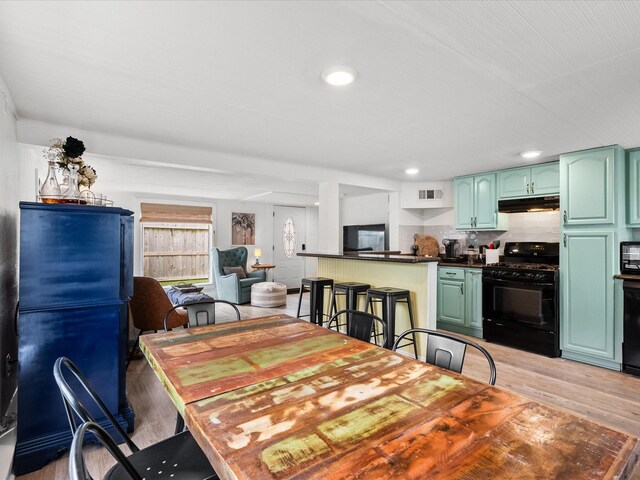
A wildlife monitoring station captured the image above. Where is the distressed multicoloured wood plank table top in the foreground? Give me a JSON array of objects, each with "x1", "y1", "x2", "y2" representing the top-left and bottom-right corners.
[{"x1": 141, "y1": 315, "x2": 638, "y2": 480}]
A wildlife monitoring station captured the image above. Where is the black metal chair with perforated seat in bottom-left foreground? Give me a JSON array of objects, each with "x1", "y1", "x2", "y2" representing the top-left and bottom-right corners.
[{"x1": 53, "y1": 357, "x2": 218, "y2": 480}]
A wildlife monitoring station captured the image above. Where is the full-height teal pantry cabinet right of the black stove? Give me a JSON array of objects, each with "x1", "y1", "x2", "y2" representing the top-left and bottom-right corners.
[{"x1": 560, "y1": 145, "x2": 631, "y2": 370}]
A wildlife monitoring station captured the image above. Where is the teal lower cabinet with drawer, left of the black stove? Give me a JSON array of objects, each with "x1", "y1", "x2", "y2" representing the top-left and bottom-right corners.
[{"x1": 437, "y1": 267, "x2": 482, "y2": 338}]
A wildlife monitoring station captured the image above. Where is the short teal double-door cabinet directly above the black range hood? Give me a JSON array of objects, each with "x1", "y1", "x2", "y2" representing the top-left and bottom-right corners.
[{"x1": 498, "y1": 162, "x2": 560, "y2": 199}]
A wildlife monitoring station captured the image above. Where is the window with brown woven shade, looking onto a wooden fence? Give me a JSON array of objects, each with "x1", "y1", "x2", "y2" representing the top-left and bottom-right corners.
[{"x1": 140, "y1": 203, "x2": 212, "y2": 285}]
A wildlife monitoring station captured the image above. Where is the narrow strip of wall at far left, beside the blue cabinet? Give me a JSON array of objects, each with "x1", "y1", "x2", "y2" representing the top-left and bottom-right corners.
[{"x1": 0, "y1": 74, "x2": 20, "y2": 479}]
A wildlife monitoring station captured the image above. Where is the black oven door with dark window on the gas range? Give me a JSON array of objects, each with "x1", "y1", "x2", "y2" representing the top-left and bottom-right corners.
[{"x1": 482, "y1": 277, "x2": 558, "y2": 332}]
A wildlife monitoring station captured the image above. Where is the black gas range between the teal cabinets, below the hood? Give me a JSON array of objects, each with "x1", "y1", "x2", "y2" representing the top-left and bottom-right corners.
[{"x1": 482, "y1": 242, "x2": 560, "y2": 357}]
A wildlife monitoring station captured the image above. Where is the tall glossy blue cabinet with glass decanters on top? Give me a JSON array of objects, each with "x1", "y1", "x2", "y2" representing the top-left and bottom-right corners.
[{"x1": 14, "y1": 202, "x2": 134, "y2": 475}]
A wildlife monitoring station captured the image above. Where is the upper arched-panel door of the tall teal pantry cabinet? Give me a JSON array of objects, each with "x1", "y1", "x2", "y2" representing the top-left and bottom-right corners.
[{"x1": 560, "y1": 147, "x2": 616, "y2": 225}]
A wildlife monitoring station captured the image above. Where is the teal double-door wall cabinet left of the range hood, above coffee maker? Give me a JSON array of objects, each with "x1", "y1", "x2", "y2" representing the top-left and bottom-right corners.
[{"x1": 454, "y1": 173, "x2": 507, "y2": 230}]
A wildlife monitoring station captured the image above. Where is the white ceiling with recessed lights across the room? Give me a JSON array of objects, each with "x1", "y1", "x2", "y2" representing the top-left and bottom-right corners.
[{"x1": 0, "y1": 0, "x2": 640, "y2": 195}]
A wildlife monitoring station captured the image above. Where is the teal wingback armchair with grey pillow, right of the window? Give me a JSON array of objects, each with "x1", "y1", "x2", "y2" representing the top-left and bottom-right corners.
[{"x1": 212, "y1": 247, "x2": 267, "y2": 304}]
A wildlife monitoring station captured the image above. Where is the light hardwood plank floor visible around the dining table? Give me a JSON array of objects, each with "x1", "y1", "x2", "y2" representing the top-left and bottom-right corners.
[{"x1": 18, "y1": 294, "x2": 640, "y2": 480}]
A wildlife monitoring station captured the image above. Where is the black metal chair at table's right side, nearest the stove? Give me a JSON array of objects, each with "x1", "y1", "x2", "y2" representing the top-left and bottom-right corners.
[{"x1": 393, "y1": 328, "x2": 496, "y2": 385}]
